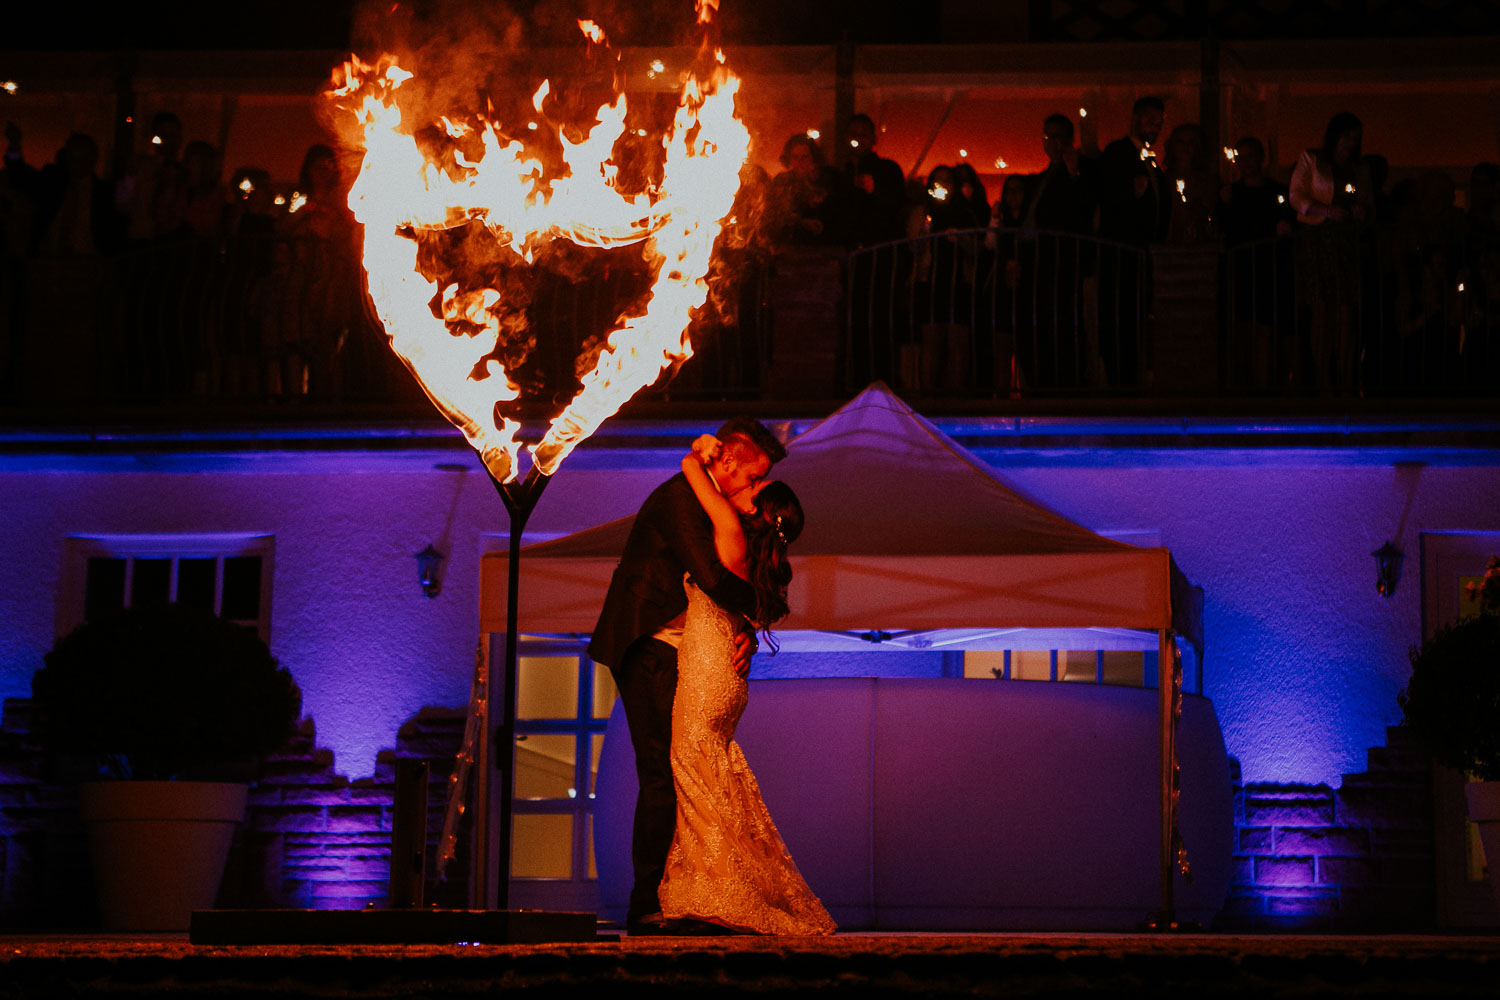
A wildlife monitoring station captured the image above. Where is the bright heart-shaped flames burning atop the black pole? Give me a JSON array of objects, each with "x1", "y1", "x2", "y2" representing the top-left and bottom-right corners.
[{"x1": 330, "y1": 13, "x2": 750, "y2": 481}]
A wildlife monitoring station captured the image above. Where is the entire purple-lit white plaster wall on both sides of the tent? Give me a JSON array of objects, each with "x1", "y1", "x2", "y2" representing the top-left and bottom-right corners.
[{"x1": 0, "y1": 450, "x2": 1500, "y2": 786}]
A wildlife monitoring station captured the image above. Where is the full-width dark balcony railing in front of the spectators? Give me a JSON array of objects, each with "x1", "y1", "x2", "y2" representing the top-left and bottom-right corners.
[{"x1": 0, "y1": 226, "x2": 1500, "y2": 417}]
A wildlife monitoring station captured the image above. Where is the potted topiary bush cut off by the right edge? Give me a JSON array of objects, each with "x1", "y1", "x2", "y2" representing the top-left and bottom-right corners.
[{"x1": 1398, "y1": 556, "x2": 1500, "y2": 903}]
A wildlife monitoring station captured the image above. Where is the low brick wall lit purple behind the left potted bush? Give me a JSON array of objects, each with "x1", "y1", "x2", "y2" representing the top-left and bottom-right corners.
[{"x1": 0, "y1": 699, "x2": 468, "y2": 930}]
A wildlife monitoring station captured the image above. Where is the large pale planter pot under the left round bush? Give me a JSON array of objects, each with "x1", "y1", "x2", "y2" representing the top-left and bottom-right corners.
[{"x1": 78, "y1": 781, "x2": 248, "y2": 931}]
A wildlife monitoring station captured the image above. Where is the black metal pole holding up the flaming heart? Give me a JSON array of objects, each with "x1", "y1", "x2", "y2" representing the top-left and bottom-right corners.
[{"x1": 474, "y1": 463, "x2": 552, "y2": 910}]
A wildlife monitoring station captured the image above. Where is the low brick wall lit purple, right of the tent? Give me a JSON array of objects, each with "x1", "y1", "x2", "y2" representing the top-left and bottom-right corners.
[{"x1": 1220, "y1": 727, "x2": 1436, "y2": 931}]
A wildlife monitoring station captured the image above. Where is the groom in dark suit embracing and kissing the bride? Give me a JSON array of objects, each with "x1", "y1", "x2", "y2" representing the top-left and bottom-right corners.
[{"x1": 588, "y1": 417, "x2": 786, "y2": 934}]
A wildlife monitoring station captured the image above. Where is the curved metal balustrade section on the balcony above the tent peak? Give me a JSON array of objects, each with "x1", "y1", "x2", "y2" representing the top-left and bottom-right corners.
[{"x1": 845, "y1": 229, "x2": 1151, "y2": 397}]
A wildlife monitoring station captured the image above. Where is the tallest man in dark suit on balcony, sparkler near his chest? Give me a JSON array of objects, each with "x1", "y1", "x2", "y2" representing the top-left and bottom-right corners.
[{"x1": 1098, "y1": 97, "x2": 1172, "y2": 388}]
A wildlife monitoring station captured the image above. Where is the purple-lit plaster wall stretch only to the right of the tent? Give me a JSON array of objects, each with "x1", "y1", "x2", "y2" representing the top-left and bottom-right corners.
[{"x1": 1001, "y1": 463, "x2": 1500, "y2": 787}]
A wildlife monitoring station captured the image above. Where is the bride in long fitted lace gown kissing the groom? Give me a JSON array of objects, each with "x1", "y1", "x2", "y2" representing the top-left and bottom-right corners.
[{"x1": 660, "y1": 435, "x2": 836, "y2": 934}]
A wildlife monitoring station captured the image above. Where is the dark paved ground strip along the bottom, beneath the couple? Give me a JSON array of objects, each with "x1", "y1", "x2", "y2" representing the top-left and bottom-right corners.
[{"x1": 0, "y1": 934, "x2": 1500, "y2": 1000}]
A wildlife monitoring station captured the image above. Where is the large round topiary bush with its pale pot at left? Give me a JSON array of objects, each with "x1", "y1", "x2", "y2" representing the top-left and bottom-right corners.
[{"x1": 32, "y1": 604, "x2": 302, "y2": 931}]
